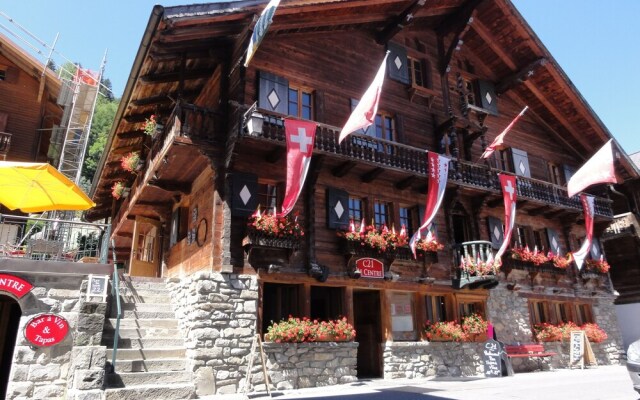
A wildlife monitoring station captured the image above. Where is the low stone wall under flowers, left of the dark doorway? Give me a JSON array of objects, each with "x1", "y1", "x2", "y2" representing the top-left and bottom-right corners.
[{"x1": 262, "y1": 342, "x2": 358, "y2": 390}]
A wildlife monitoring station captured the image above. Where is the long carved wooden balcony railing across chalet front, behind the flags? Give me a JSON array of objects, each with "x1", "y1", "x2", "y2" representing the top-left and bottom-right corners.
[{"x1": 241, "y1": 110, "x2": 613, "y2": 218}]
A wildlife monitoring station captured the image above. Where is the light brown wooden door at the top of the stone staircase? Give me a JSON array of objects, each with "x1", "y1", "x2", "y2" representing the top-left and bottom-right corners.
[{"x1": 129, "y1": 217, "x2": 162, "y2": 277}]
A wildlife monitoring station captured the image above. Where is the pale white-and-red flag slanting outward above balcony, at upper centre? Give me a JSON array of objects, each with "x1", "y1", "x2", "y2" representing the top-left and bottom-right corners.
[{"x1": 338, "y1": 51, "x2": 389, "y2": 143}]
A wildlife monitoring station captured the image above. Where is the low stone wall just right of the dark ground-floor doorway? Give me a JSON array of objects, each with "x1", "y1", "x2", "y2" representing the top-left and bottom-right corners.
[{"x1": 382, "y1": 341, "x2": 484, "y2": 379}]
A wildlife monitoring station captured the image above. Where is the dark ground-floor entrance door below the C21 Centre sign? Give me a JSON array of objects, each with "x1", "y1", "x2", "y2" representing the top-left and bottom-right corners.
[{"x1": 353, "y1": 290, "x2": 382, "y2": 378}]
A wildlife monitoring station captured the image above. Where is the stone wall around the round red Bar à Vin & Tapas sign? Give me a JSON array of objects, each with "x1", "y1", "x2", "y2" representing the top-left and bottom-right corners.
[{"x1": 6, "y1": 271, "x2": 106, "y2": 399}]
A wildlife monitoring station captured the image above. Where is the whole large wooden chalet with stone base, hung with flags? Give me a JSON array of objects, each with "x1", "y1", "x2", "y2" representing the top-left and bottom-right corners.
[{"x1": 88, "y1": 0, "x2": 638, "y2": 394}]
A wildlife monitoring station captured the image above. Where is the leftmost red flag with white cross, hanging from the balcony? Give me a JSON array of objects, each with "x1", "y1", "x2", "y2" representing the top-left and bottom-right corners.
[{"x1": 279, "y1": 118, "x2": 317, "y2": 216}]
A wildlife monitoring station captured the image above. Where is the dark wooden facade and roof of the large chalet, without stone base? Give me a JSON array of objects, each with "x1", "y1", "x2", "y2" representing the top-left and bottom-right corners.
[{"x1": 89, "y1": 0, "x2": 638, "y2": 366}]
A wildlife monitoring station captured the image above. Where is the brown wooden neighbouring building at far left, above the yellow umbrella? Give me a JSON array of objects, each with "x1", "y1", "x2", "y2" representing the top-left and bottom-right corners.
[{"x1": 0, "y1": 35, "x2": 62, "y2": 162}]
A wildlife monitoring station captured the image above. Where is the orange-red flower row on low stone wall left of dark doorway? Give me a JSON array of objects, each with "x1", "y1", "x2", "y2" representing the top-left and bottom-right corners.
[{"x1": 265, "y1": 316, "x2": 356, "y2": 343}]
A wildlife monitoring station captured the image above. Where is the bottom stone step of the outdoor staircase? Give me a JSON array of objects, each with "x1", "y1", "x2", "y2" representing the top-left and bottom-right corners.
[{"x1": 104, "y1": 383, "x2": 196, "y2": 400}]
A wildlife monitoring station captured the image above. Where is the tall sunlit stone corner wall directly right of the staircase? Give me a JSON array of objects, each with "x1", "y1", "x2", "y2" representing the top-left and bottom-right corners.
[{"x1": 167, "y1": 272, "x2": 259, "y2": 396}]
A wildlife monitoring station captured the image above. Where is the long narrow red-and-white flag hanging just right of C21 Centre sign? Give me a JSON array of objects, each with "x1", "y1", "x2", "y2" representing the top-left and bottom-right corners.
[{"x1": 409, "y1": 151, "x2": 450, "y2": 258}]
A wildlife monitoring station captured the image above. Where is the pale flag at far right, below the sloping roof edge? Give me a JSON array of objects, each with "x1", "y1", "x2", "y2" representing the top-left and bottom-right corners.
[{"x1": 567, "y1": 139, "x2": 617, "y2": 197}]
